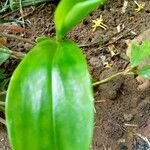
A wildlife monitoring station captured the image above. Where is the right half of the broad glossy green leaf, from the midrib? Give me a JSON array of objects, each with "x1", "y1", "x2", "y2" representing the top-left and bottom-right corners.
[{"x1": 52, "y1": 41, "x2": 94, "y2": 150}]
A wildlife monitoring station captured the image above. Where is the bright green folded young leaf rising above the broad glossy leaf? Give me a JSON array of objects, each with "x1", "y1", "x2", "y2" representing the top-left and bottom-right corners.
[{"x1": 55, "y1": 0, "x2": 107, "y2": 38}]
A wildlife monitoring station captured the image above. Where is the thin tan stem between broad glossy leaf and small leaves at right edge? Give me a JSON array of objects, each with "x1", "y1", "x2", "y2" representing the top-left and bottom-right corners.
[{"x1": 92, "y1": 69, "x2": 134, "y2": 86}]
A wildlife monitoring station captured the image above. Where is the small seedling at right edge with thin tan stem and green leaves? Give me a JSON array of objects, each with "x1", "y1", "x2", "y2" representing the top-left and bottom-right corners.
[{"x1": 93, "y1": 41, "x2": 150, "y2": 86}]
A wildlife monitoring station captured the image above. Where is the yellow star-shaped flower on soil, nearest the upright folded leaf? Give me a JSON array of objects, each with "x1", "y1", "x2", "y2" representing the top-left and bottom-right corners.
[{"x1": 92, "y1": 15, "x2": 107, "y2": 32}]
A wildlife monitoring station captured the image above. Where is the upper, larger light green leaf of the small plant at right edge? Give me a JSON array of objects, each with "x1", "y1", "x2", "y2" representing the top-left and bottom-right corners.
[{"x1": 131, "y1": 41, "x2": 150, "y2": 67}]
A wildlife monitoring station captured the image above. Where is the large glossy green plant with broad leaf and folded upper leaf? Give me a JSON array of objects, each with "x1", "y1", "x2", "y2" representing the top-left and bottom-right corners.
[{"x1": 6, "y1": 0, "x2": 105, "y2": 150}]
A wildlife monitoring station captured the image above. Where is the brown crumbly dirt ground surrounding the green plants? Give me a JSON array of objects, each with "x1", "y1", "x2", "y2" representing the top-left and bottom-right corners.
[{"x1": 0, "y1": 0, "x2": 150, "y2": 150}]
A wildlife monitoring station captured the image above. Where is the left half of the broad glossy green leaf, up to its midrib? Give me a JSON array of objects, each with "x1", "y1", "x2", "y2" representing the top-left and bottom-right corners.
[{"x1": 6, "y1": 40, "x2": 57, "y2": 150}]
